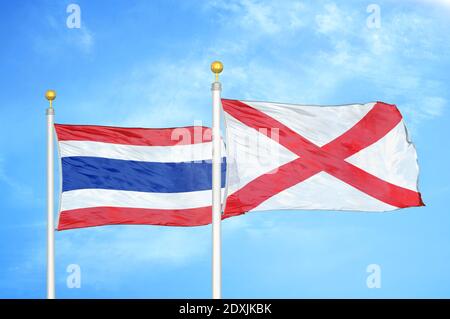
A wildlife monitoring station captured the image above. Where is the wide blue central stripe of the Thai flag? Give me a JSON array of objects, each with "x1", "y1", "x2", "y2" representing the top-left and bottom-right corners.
[{"x1": 61, "y1": 156, "x2": 226, "y2": 193}]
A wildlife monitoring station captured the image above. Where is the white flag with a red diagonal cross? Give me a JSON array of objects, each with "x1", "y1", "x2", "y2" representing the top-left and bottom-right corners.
[{"x1": 222, "y1": 99, "x2": 424, "y2": 217}]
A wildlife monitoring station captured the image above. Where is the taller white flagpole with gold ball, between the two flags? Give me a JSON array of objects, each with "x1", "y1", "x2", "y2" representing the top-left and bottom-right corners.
[{"x1": 211, "y1": 61, "x2": 223, "y2": 299}]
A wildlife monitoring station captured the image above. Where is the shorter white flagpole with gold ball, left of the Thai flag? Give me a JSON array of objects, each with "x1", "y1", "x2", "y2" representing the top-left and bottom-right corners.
[{"x1": 45, "y1": 90, "x2": 56, "y2": 299}]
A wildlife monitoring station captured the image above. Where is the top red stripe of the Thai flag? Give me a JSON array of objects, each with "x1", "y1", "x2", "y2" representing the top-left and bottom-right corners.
[{"x1": 55, "y1": 124, "x2": 212, "y2": 146}]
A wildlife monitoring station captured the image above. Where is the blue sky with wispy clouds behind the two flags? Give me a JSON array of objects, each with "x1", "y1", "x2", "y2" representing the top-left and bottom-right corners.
[{"x1": 0, "y1": 0, "x2": 450, "y2": 298}]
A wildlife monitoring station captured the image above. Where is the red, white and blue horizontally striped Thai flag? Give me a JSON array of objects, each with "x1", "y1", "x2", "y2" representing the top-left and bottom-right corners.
[{"x1": 55, "y1": 124, "x2": 226, "y2": 230}]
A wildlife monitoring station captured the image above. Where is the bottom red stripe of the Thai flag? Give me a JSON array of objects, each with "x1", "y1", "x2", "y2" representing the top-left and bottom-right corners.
[{"x1": 58, "y1": 206, "x2": 212, "y2": 230}]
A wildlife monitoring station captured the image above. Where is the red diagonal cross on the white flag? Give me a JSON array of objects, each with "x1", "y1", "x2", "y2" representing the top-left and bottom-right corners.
[{"x1": 222, "y1": 99, "x2": 424, "y2": 218}]
